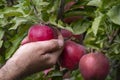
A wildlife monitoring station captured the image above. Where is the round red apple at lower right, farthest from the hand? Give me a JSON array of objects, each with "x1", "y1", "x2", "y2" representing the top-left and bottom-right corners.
[{"x1": 79, "y1": 52, "x2": 109, "y2": 80}]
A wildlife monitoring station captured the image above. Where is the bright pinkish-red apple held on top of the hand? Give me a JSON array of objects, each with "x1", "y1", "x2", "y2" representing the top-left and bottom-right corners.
[{"x1": 28, "y1": 24, "x2": 55, "y2": 42}]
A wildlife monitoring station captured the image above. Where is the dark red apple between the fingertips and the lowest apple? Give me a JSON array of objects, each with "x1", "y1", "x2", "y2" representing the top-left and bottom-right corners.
[{"x1": 59, "y1": 40, "x2": 86, "y2": 70}]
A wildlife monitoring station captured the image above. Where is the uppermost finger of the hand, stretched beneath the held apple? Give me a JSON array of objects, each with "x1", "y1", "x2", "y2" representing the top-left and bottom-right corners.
[{"x1": 21, "y1": 39, "x2": 60, "y2": 54}]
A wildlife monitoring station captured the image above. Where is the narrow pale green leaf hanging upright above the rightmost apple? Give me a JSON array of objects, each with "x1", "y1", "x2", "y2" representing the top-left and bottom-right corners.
[{"x1": 92, "y1": 14, "x2": 103, "y2": 36}]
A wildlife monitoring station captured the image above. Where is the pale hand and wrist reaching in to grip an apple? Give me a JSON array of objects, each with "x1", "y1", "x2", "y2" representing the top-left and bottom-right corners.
[{"x1": 0, "y1": 32, "x2": 64, "y2": 80}]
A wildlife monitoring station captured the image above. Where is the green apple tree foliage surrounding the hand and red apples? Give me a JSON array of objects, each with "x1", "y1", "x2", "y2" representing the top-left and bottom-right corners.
[{"x1": 0, "y1": 0, "x2": 120, "y2": 80}]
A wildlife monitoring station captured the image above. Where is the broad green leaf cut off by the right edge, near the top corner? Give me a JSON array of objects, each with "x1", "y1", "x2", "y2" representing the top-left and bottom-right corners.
[{"x1": 107, "y1": 5, "x2": 120, "y2": 25}]
